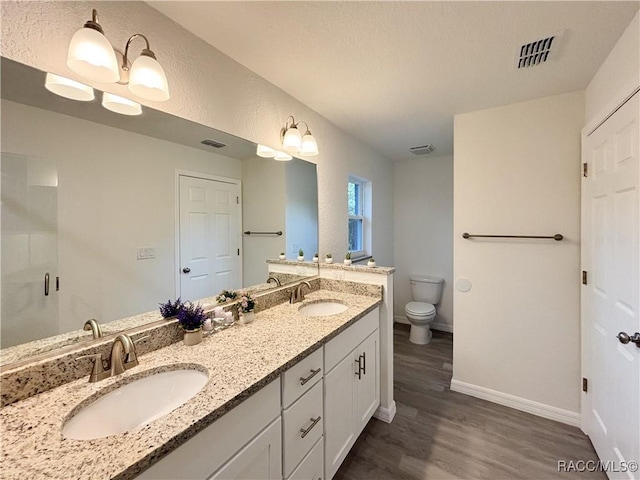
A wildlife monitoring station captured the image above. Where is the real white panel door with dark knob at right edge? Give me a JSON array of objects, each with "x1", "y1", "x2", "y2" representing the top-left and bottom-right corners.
[{"x1": 582, "y1": 93, "x2": 640, "y2": 479}]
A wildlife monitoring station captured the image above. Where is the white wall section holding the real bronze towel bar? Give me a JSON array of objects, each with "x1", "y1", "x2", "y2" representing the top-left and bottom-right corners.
[{"x1": 452, "y1": 92, "x2": 584, "y2": 424}]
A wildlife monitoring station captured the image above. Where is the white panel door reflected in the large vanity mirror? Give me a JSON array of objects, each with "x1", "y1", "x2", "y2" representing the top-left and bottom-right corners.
[{"x1": 179, "y1": 175, "x2": 242, "y2": 300}]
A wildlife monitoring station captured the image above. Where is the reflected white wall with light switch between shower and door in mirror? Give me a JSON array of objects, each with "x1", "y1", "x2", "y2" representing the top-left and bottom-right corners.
[{"x1": 2, "y1": 100, "x2": 242, "y2": 333}]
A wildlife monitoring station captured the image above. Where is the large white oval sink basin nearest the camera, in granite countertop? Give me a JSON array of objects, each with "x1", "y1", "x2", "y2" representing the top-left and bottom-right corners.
[{"x1": 62, "y1": 369, "x2": 209, "y2": 440}]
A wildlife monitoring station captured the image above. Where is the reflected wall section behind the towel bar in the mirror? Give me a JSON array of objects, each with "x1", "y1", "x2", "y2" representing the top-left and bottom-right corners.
[{"x1": 242, "y1": 157, "x2": 284, "y2": 285}]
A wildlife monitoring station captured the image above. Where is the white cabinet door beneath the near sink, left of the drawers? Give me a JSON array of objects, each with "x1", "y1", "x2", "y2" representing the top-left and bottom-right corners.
[{"x1": 208, "y1": 418, "x2": 282, "y2": 480}]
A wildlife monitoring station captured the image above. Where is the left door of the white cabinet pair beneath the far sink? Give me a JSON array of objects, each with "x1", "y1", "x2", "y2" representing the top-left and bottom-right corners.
[{"x1": 324, "y1": 350, "x2": 357, "y2": 478}]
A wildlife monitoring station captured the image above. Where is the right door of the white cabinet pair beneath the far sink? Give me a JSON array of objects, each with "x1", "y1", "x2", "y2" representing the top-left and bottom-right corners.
[{"x1": 353, "y1": 330, "x2": 380, "y2": 435}]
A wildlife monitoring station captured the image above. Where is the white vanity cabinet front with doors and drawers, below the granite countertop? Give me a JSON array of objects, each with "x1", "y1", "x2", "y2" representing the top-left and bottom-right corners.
[{"x1": 132, "y1": 308, "x2": 380, "y2": 480}]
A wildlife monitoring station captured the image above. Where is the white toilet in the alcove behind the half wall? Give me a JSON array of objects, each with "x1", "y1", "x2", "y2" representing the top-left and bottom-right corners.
[{"x1": 404, "y1": 275, "x2": 444, "y2": 345}]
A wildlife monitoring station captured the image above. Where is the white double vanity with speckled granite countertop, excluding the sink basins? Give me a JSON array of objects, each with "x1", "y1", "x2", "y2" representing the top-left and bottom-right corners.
[{"x1": 0, "y1": 285, "x2": 382, "y2": 479}]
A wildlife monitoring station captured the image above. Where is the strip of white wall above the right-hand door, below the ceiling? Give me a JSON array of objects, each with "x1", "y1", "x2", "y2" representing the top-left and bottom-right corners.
[{"x1": 585, "y1": 12, "x2": 640, "y2": 122}]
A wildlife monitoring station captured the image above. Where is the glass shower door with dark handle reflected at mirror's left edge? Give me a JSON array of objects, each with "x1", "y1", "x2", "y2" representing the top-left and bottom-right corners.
[{"x1": 0, "y1": 152, "x2": 59, "y2": 348}]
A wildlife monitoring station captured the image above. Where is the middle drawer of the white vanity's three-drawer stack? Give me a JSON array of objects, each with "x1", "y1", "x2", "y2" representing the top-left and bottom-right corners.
[{"x1": 282, "y1": 382, "x2": 324, "y2": 478}]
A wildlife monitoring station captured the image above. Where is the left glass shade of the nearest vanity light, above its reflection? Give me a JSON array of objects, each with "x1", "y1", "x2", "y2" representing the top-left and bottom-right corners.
[{"x1": 67, "y1": 27, "x2": 120, "y2": 83}]
